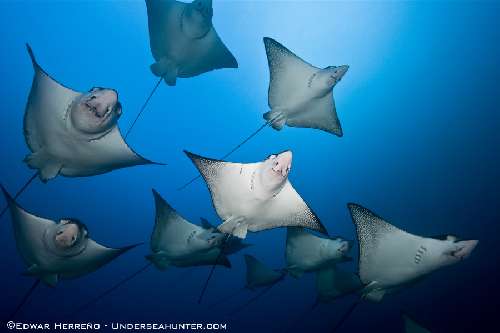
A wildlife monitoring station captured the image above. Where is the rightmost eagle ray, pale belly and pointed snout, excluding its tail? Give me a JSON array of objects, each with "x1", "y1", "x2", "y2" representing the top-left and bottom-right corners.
[{"x1": 348, "y1": 204, "x2": 478, "y2": 301}]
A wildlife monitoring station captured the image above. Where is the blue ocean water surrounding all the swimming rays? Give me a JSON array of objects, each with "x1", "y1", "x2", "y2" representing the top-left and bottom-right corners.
[{"x1": 0, "y1": 1, "x2": 500, "y2": 332}]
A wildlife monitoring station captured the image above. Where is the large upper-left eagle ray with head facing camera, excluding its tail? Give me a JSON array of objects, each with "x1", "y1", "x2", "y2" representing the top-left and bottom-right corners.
[{"x1": 24, "y1": 46, "x2": 152, "y2": 181}]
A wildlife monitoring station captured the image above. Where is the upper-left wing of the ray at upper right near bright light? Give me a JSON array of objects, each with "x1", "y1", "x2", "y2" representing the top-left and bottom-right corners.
[{"x1": 264, "y1": 37, "x2": 319, "y2": 108}]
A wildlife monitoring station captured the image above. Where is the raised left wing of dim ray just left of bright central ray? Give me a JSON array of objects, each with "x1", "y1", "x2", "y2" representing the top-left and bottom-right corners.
[{"x1": 151, "y1": 190, "x2": 202, "y2": 256}]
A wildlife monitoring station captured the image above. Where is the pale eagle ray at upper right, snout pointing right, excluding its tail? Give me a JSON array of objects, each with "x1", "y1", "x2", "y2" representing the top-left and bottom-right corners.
[{"x1": 264, "y1": 37, "x2": 349, "y2": 136}]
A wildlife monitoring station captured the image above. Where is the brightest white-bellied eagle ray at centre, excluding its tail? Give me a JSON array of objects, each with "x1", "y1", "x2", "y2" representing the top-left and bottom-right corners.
[{"x1": 186, "y1": 151, "x2": 326, "y2": 238}]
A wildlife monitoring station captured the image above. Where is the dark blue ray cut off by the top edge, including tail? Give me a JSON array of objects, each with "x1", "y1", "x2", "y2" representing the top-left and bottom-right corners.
[{"x1": 125, "y1": 0, "x2": 238, "y2": 137}]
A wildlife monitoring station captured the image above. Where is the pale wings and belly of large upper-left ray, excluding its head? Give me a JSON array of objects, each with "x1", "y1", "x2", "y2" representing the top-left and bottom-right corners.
[{"x1": 24, "y1": 46, "x2": 153, "y2": 181}]
